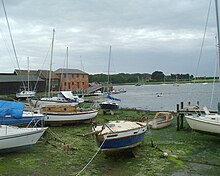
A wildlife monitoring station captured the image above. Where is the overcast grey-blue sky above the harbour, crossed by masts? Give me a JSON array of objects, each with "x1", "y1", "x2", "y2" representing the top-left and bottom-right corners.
[{"x1": 0, "y1": 0, "x2": 217, "y2": 76}]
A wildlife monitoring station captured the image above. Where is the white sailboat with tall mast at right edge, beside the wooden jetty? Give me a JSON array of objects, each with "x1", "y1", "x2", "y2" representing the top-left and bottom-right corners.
[{"x1": 185, "y1": 0, "x2": 220, "y2": 135}]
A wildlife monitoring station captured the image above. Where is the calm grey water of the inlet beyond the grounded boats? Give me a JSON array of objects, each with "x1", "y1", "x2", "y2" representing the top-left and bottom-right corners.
[{"x1": 114, "y1": 83, "x2": 220, "y2": 111}]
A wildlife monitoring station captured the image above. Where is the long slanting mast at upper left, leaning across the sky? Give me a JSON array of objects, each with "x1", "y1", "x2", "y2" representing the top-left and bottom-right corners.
[{"x1": 2, "y1": 0, "x2": 26, "y2": 90}]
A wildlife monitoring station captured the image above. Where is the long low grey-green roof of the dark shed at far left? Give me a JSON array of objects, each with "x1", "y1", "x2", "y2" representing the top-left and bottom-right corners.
[{"x1": 0, "y1": 74, "x2": 43, "y2": 83}]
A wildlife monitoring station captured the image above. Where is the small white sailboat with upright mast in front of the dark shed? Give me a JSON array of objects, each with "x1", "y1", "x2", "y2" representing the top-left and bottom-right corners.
[{"x1": 16, "y1": 57, "x2": 36, "y2": 99}]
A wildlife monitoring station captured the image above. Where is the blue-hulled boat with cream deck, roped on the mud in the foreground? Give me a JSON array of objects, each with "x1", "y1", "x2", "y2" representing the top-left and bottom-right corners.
[{"x1": 92, "y1": 120, "x2": 147, "y2": 152}]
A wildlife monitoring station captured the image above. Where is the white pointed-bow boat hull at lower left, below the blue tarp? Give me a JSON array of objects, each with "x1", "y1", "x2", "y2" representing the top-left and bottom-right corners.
[{"x1": 0, "y1": 125, "x2": 47, "y2": 152}]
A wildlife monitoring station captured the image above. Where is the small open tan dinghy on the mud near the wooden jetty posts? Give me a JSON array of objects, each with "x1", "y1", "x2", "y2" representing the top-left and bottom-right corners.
[{"x1": 148, "y1": 112, "x2": 174, "y2": 129}]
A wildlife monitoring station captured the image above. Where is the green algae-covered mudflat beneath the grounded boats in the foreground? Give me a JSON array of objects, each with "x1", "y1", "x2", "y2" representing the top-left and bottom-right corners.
[{"x1": 0, "y1": 109, "x2": 220, "y2": 176}]
